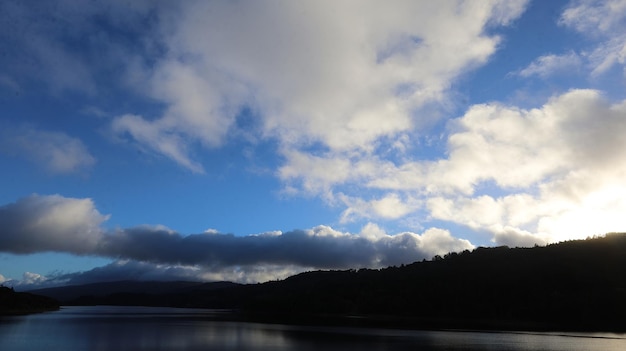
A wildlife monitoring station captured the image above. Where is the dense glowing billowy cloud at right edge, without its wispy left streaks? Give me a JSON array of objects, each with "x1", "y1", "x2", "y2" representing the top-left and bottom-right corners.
[{"x1": 428, "y1": 90, "x2": 626, "y2": 245}]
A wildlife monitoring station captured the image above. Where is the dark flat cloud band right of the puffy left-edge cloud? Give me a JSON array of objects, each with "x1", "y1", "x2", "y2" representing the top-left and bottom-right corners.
[{"x1": 95, "y1": 226, "x2": 472, "y2": 269}]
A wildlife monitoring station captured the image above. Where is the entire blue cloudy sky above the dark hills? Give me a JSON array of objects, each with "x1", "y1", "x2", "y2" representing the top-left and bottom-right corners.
[{"x1": 0, "y1": 0, "x2": 626, "y2": 289}]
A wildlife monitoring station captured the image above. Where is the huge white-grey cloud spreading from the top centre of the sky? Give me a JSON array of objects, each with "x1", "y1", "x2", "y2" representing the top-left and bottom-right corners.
[{"x1": 109, "y1": 1, "x2": 526, "y2": 171}]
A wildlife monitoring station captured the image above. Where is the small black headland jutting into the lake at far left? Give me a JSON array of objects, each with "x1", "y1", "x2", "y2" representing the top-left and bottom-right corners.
[{"x1": 0, "y1": 286, "x2": 59, "y2": 316}]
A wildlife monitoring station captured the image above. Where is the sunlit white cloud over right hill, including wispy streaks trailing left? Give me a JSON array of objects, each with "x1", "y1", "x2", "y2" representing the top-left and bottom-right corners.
[{"x1": 274, "y1": 89, "x2": 626, "y2": 246}]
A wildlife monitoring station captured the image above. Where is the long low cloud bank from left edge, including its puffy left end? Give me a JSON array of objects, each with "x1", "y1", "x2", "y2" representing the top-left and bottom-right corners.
[{"x1": 0, "y1": 195, "x2": 473, "y2": 280}]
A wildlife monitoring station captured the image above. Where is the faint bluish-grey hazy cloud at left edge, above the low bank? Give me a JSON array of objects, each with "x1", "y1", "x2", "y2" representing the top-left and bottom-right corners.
[{"x1": 0, "y1": 126, "x2": 96, "y2": 174}]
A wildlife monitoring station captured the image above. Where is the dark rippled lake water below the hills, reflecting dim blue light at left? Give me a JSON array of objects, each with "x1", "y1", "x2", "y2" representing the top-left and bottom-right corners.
[{"x1": 0, "y1": 306, "x2": 626, "y2": 351}]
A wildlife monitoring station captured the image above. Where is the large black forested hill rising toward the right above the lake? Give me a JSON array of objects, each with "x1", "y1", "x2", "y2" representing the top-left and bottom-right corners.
[{"x1": 29, "y1": 234, "x2": 626, "y2": 331}]
